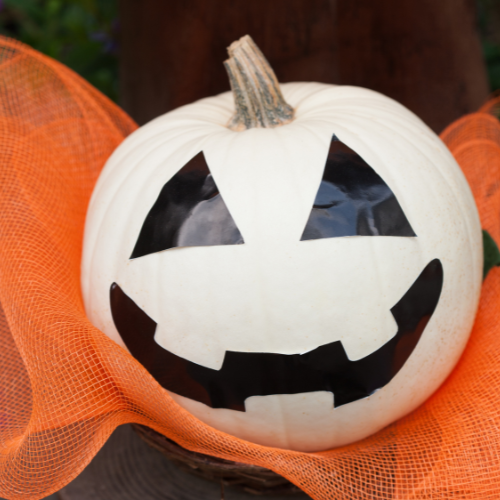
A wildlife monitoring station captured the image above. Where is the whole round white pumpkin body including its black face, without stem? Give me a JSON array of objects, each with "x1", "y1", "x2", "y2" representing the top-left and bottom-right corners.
[{"x1": 82, "y1": 84, "x2": 481, "y2": 451}]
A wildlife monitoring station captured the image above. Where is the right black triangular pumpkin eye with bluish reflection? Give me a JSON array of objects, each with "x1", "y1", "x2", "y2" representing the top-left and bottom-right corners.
[{"x1": 301, "y1": 135, "x2": 416, "y2": 241}]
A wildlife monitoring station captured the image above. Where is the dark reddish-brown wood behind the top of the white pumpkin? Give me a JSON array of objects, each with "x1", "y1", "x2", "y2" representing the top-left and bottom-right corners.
[{"x1": 120, "y1": 0, "x2": 488, "y2": 131}]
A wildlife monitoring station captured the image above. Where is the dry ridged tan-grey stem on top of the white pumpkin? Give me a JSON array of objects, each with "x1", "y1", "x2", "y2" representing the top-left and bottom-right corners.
[{"x1": 224, "y1": 35, "x2": 294, "y2": 131}]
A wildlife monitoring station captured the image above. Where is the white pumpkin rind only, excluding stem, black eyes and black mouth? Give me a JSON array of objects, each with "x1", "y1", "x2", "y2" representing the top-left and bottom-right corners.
[{"x1": 82, "y1": 36, "x2": 482, "y2": 451}]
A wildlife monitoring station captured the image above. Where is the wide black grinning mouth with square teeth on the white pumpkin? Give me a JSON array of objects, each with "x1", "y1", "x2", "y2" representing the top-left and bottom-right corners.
[{"x1": 110, "y1": 259, "x2": 443, "y2": 411}]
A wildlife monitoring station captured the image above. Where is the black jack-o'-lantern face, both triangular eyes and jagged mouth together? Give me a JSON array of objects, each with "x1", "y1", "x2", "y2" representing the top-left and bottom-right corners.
[{"x1": 110, "y1": 136, "x2": 443, "y2": 411}]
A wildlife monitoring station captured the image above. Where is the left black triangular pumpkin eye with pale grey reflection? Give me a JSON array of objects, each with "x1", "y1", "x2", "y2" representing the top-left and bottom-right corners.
[{"x1": 130, "y1": 152, "x2": 244, "y2": 259}]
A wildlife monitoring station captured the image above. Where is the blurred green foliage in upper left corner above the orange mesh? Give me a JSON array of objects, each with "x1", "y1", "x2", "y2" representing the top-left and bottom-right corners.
[{"x1": 0, "y1": 0, "x2": 118, "y2": 101}]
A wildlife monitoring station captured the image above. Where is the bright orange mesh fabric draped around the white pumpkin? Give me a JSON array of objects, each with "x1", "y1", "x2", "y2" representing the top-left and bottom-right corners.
[{"x1": 0, "y1": 39, "x2": 500, "y2": 500}]
